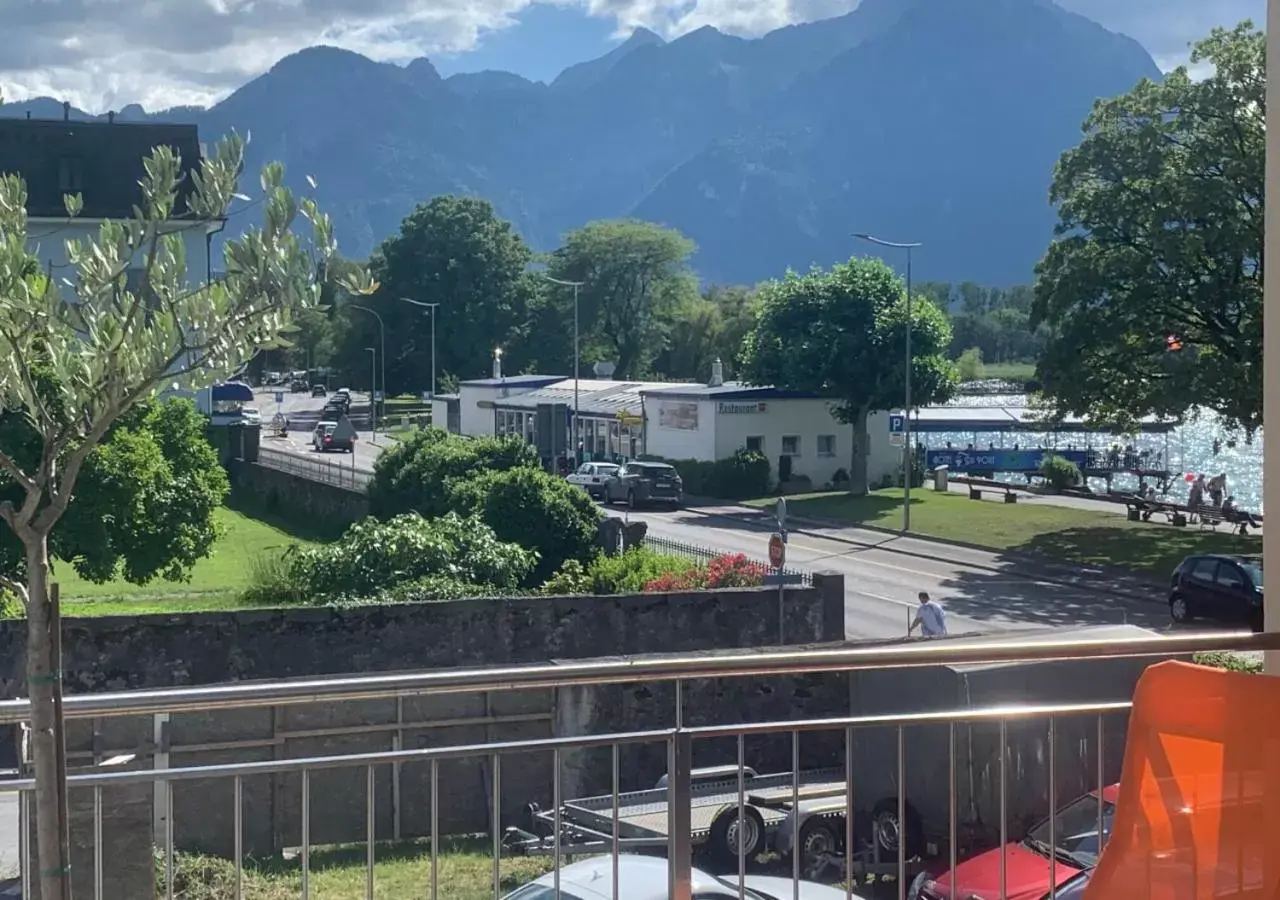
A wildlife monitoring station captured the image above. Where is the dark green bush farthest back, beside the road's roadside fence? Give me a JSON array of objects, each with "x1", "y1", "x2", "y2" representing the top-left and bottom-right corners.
[{"x1": 369, "y1": 428, "x2": 539, "y2": 518}]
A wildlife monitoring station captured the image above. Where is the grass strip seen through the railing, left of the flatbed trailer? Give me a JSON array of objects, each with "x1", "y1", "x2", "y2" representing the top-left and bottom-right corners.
[{"x1": 170, "y1": 840, "x2": 550, "y2": 900}]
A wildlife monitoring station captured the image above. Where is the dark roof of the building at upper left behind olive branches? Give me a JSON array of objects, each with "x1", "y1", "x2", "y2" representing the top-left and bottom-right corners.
[{"x1": 0, "y1": 118, "x2": 201, "y2": 219}]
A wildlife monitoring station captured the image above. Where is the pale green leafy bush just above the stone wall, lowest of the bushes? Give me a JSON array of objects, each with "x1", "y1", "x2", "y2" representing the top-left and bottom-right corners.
[{"x1": 288, "y1": 513, "x2": 536, "y2": 603}]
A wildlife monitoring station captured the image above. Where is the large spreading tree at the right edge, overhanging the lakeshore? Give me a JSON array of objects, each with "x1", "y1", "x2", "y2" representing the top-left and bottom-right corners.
[{"x1": 1032, "y1": 22, "x2": 1266, "y2": 431}]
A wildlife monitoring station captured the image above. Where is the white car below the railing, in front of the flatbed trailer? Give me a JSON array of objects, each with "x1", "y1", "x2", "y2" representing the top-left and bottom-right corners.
[{"x1": 506, "y1": 854, "x2": 858, "y2": 900}]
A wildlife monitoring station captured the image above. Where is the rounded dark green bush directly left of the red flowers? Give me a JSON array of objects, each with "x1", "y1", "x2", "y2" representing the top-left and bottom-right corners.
[{"x1": 449, "y1": 467, "x2": 602, "y2": 584}]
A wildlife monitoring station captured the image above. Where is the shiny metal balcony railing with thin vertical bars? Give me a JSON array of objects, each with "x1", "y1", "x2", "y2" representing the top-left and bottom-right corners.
[{"x1": 0, "y1": 634, "x2": 1280, "y2": 900}]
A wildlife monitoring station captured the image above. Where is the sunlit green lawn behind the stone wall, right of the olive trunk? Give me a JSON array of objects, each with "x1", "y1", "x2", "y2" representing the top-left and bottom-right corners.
[{"x1": 54, "y1": 507, "x2": 317, "y2": 616}]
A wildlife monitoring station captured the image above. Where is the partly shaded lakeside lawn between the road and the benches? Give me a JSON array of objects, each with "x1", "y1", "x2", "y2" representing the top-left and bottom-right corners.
[{"x1": 748, "y1": 489, "x2": 1262, "y2": 577}]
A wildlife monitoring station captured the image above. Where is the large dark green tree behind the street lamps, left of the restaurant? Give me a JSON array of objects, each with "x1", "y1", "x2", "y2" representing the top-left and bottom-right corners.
[{"x1": 337, "y1": 196, "x2": 535, "y2": 394}]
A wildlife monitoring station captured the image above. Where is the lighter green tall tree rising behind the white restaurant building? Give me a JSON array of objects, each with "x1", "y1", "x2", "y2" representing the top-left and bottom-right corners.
[{"x1": 548, "y1": 219, "x2": 698, "y2": 379}]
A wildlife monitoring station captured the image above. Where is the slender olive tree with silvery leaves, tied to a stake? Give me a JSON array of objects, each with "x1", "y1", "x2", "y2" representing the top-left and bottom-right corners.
[{"x1": 0, "y1": 136, "x2": 374, "y2": 900}]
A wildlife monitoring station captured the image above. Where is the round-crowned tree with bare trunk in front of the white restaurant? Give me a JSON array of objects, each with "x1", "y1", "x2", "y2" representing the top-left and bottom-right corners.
[{"x1": 742, "y1": 259, "x2": 956, "y2": 494}]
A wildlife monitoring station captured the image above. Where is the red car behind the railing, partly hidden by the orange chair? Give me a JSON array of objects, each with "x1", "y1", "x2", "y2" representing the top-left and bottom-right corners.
[{"x1": 908, "y1": 785, "x2": 1120, "y2": 900}]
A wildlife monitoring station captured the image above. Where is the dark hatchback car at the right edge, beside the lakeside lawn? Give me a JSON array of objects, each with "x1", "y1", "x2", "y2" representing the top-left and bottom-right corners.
[{"x1": 1169, "y1": 553, "x2": 1262, "y2": 631}]
